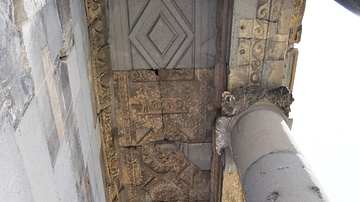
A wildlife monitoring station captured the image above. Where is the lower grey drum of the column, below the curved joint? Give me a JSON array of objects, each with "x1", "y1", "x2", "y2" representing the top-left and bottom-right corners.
[{"x1": 243, "y1": 152, "x2": 327, "y2": 202}]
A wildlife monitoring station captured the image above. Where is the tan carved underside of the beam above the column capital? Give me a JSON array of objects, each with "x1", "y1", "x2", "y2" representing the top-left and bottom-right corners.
[{"x1": 228, "y1": 0, "x2": 305, "y2": 90}]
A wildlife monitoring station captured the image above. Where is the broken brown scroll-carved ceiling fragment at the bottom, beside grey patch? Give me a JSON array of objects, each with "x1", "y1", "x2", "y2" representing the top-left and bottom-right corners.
[{"x1": 120, "y1": 142, "x2": 210, "y2": 202}]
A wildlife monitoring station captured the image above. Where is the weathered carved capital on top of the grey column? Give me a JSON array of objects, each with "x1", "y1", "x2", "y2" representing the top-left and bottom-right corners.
[{"x1": 222, "y1": 86, "x2": 294, "y2": 116}]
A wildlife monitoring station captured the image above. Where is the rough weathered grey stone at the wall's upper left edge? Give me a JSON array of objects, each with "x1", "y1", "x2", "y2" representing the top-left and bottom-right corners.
[{"x1": 0, "y1": 0, "x2": 34, "y2": 128}]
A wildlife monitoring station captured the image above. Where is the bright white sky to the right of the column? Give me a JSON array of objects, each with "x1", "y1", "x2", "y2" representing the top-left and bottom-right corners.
[{"x1": 290, "y1": 0, "x2": 360, "y2": 202}]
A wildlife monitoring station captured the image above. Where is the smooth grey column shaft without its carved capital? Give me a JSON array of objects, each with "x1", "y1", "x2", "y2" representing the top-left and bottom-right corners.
[{"x1": 231, "y1": 106, "x2": 326, "y2": 202}]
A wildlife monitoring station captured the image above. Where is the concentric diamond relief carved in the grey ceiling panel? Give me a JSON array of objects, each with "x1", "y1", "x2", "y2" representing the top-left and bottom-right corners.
[{"x1": 129, "y1": 1, "x2": 194, "y2": 69}]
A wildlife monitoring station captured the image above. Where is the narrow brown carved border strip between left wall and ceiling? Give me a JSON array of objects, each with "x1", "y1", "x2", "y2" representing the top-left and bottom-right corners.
[{"x1": 85, "y1": 0, "x2": 119, "y2": 201}]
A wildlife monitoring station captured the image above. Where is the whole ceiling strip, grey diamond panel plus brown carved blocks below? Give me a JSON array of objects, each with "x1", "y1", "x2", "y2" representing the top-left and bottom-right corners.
[{"x1": 109, "y1": 0, "x2": 217, "y2": 202}]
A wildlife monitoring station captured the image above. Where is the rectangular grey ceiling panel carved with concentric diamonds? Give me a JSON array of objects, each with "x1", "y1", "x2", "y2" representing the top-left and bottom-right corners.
[{"x1": 109, "y1": 0, "x2": 217, "y2": 70}]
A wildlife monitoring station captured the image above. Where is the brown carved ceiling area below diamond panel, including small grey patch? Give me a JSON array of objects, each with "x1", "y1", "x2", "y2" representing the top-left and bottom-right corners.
[{"x1": 114, "y1": 69, "x2": 216, "y2": 201}]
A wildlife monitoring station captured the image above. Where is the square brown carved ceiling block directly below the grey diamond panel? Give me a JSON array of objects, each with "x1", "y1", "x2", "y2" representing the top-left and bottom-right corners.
[{"x1": 114, "y1": 69, "x2": 217, "y2": 146}]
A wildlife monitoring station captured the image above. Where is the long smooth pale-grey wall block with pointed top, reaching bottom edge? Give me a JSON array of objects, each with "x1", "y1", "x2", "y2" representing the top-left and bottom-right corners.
[{"x1": 15, "y1": 100, "x2": 57, "y2": 201}]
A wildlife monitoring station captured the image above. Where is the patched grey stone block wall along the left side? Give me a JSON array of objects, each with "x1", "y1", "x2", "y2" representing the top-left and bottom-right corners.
[{"x1": 0, "y1": 0, "x2": 105, "y2": 201}]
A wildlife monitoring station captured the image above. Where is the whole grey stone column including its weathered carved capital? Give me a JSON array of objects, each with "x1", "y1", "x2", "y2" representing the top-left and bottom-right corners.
[{"x1": 218, "y1": 87, "x2": 327, "y2": 202}]
